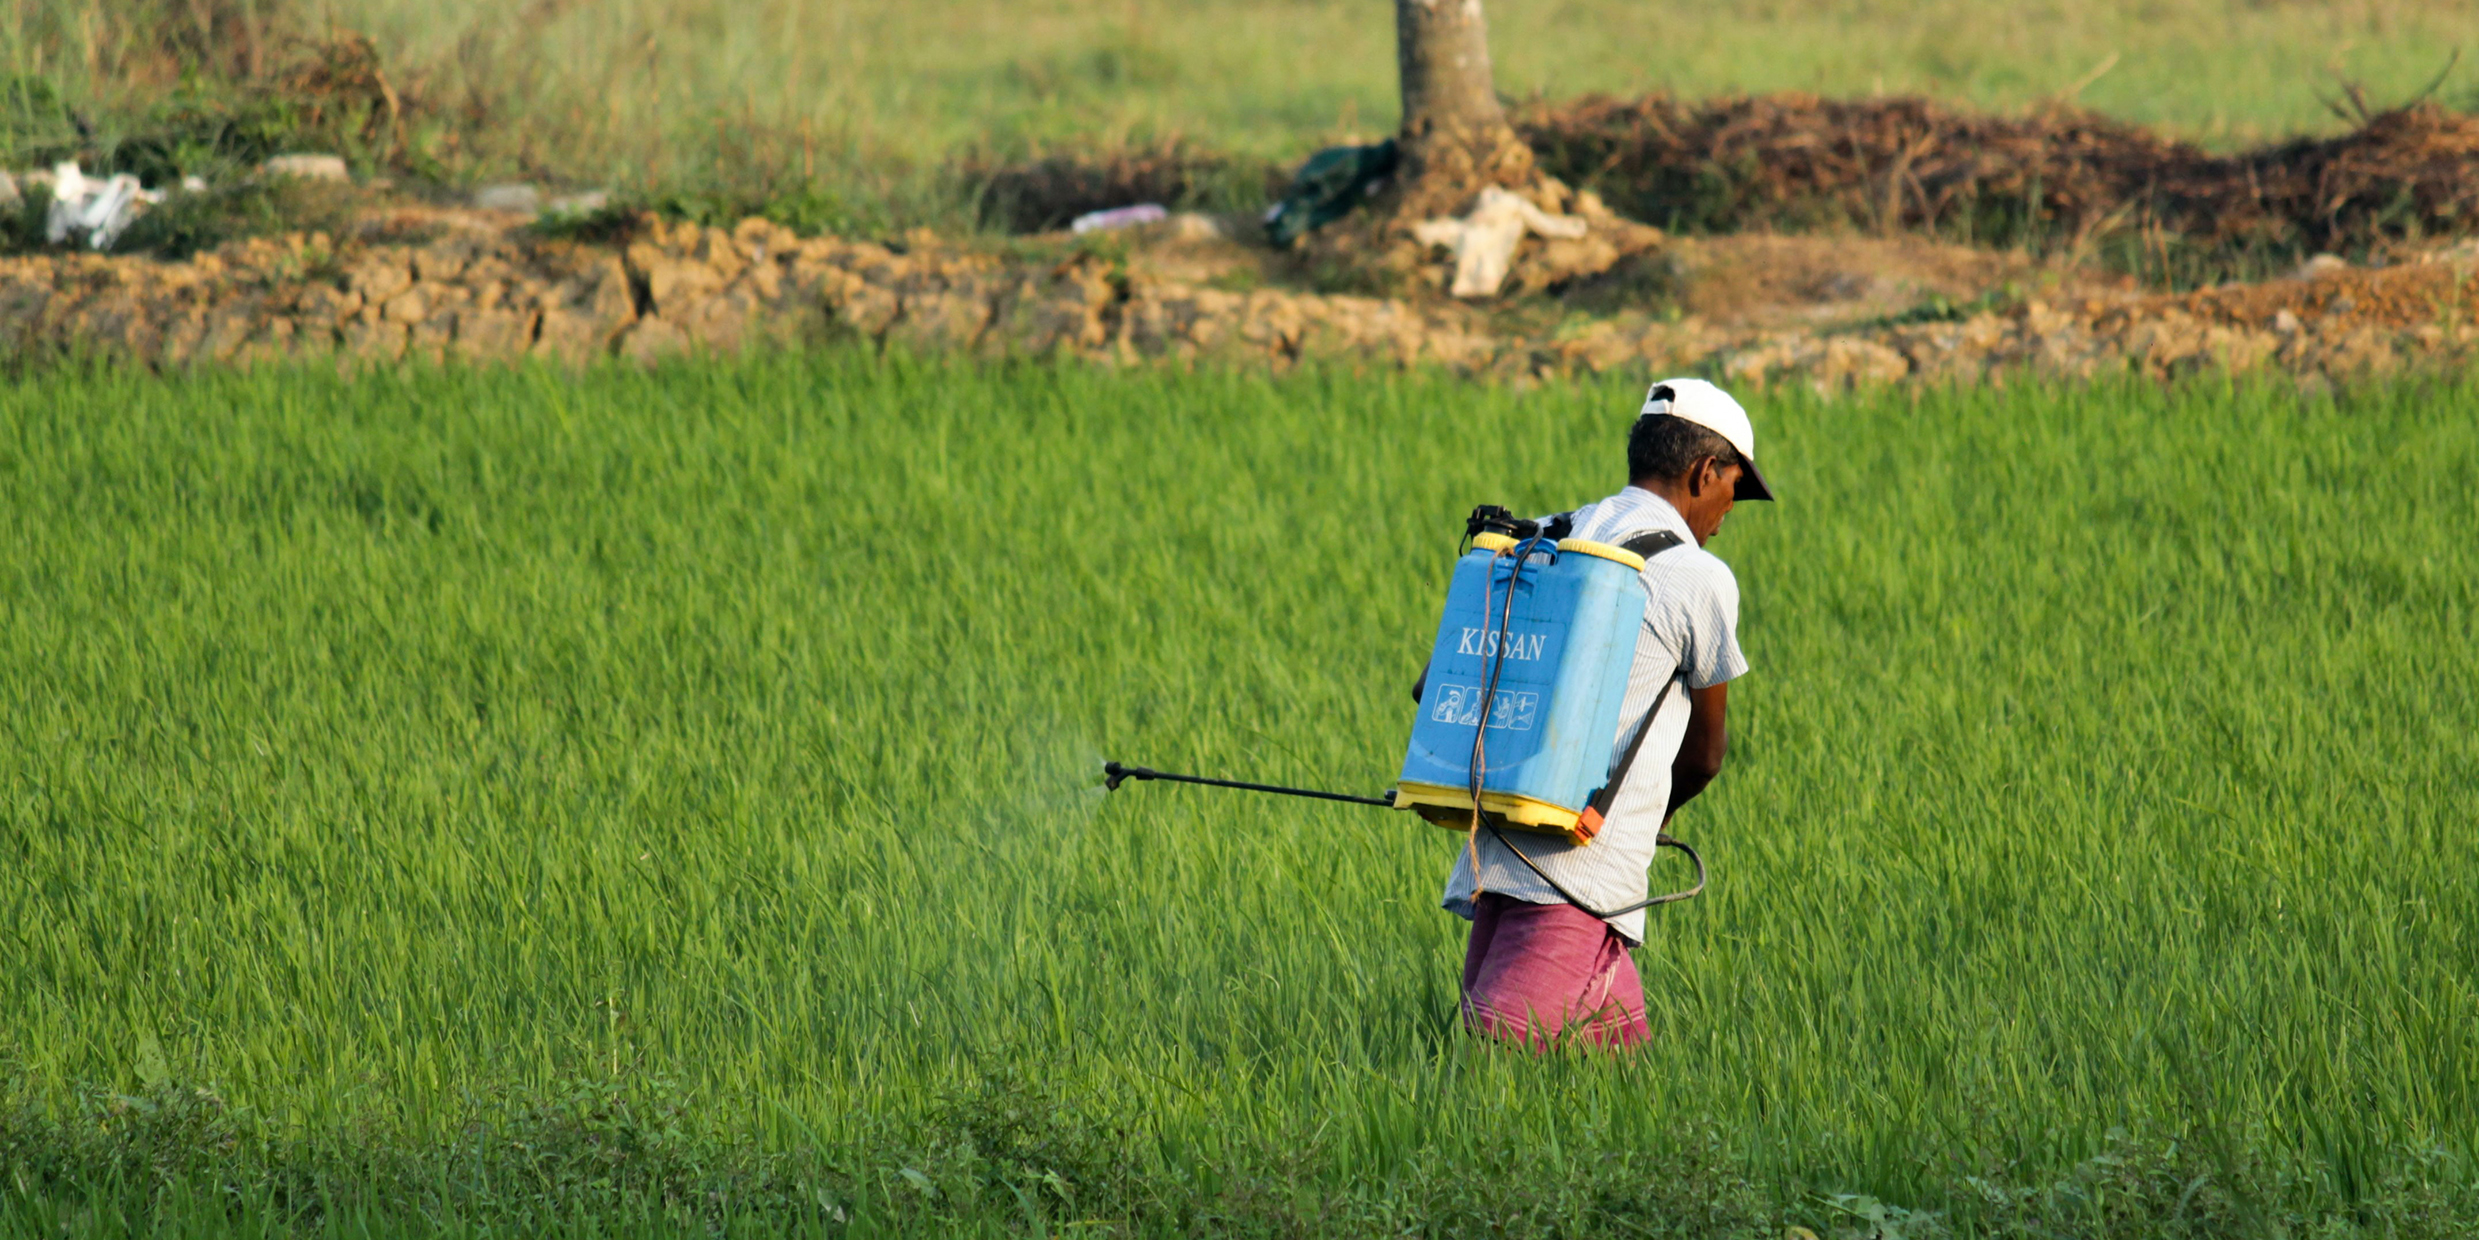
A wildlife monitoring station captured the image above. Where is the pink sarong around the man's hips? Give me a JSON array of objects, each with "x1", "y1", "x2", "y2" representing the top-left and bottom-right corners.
[{"x1": 1463, "y1": 890, "x2": 1653, "y2": 1049}]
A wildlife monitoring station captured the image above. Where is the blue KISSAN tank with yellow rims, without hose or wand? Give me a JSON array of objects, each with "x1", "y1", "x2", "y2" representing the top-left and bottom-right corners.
[{"x1": 1396, "y1": 533, "x2": 1644, "y2": 843}]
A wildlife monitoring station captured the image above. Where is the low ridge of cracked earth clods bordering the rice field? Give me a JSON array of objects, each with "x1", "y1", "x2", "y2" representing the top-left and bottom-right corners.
[{"x1": 0, "y1": 221, "x2": 2479, "y2": 387}]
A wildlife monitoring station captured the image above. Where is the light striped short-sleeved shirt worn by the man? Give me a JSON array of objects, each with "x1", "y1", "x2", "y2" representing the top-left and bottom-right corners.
[{"x1": 1445, "y1": 486, "x2": 1748, "y2": 942}]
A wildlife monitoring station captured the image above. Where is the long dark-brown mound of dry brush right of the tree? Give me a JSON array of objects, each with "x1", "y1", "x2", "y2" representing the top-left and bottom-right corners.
[{"x1": 1517, "y1": 94, "x2": 2479, "y2": 266}]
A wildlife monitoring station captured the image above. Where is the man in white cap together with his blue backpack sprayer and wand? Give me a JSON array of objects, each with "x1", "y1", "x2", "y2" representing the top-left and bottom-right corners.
[{"x1": 1103, "y1": 379, "x2": 1772, "y2": 1047}]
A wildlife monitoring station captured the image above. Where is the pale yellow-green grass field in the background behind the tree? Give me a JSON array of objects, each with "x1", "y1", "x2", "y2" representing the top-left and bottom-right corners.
[{"x1": 0, "y1": 0, "x2": 2479, "y2": 228}]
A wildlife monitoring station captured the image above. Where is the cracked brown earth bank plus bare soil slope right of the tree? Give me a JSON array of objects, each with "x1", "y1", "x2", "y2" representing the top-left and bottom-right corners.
[{"x1": 0, "y1": 179, "x2": 2479, "y2": 389}]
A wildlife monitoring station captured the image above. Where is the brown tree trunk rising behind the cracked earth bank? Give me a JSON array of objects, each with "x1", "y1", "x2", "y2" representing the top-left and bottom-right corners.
[{"x1": 1396, "y1": 0, "x2": 1532, "y2": 216}]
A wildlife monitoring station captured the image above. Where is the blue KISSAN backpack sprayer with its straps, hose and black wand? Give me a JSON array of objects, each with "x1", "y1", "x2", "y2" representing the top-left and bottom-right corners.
[{"x1": 1103, "y1": 503, "x2": 1706, "y2": 918}]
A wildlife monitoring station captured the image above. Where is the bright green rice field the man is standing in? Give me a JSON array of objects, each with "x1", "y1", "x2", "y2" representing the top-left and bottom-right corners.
[{"x1": 0, "y1": 355, "x2": 2479, "y2": 1238}]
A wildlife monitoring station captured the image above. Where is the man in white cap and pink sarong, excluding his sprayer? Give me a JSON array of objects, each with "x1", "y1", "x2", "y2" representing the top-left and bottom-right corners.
[{"x1": 1445, "y1": 379, "x2": 1772, "y2": 1047}]
